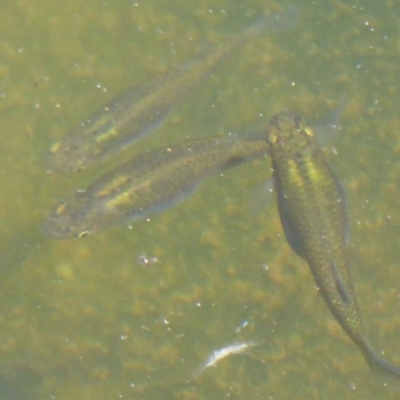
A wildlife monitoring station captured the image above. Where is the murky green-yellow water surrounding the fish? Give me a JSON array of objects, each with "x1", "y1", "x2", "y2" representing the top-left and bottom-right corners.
[{"x1": 0, "y1": 0, "x2": 400, "y2": 400}]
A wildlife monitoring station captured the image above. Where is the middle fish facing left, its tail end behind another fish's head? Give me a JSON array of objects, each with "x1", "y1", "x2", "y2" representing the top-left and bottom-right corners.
[{"x1": 44, "y1": 131, "x2": 268, "y2": 239}]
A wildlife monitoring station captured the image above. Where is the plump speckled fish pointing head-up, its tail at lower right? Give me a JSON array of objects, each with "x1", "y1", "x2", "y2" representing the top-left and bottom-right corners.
[{"x1": 267, "y1": 111, "x2": 400, "y2": 383}]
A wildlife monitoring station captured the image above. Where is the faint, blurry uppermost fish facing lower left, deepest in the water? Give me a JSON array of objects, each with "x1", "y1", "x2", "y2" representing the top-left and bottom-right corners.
[{"x1": 45, "y1": 7, "x2": 298, "y2": 173}]
